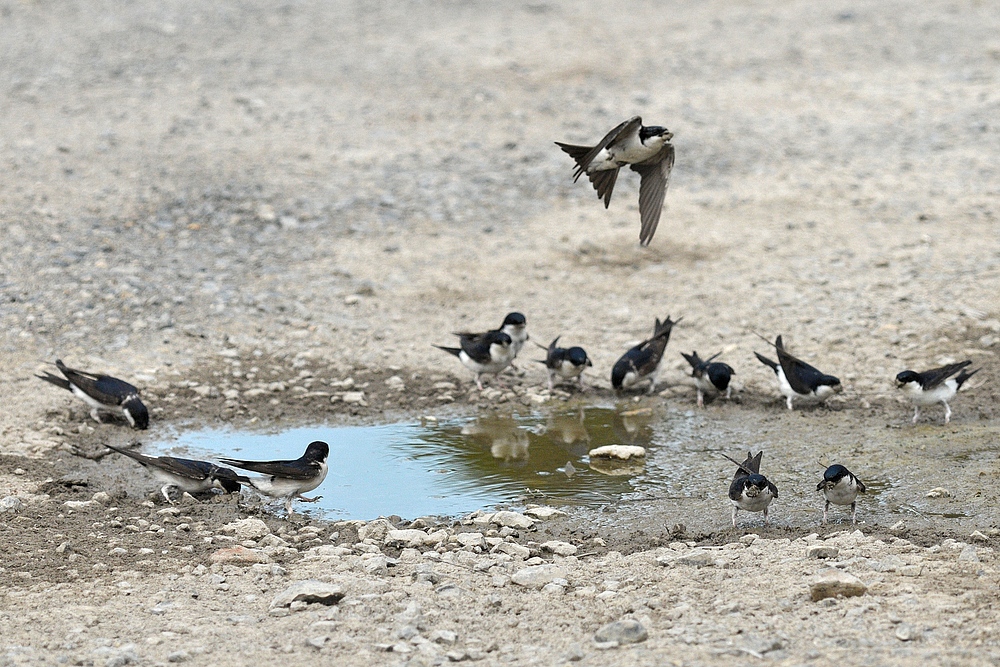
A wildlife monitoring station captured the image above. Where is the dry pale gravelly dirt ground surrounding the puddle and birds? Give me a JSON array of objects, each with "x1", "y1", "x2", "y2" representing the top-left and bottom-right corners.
[{"x1": 0, "y1": 0, "x2": 1000, "y2": 666}]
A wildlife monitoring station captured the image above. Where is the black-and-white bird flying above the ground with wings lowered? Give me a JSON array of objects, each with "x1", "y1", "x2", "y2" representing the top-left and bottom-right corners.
[{"x1": 555, "y1": 116, "x2": 674, "y2": 246}]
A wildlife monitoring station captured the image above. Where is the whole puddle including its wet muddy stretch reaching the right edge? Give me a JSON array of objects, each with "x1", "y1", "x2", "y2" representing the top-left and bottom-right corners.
[{"x1": 153, "y1": 405, "x2": 1000, "y2": 533}]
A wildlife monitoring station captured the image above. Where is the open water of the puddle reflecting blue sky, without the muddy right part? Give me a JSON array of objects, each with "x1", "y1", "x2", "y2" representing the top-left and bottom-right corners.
[{"x1": 154, "y1": 407, "x2": 678, "y2": 520}]
